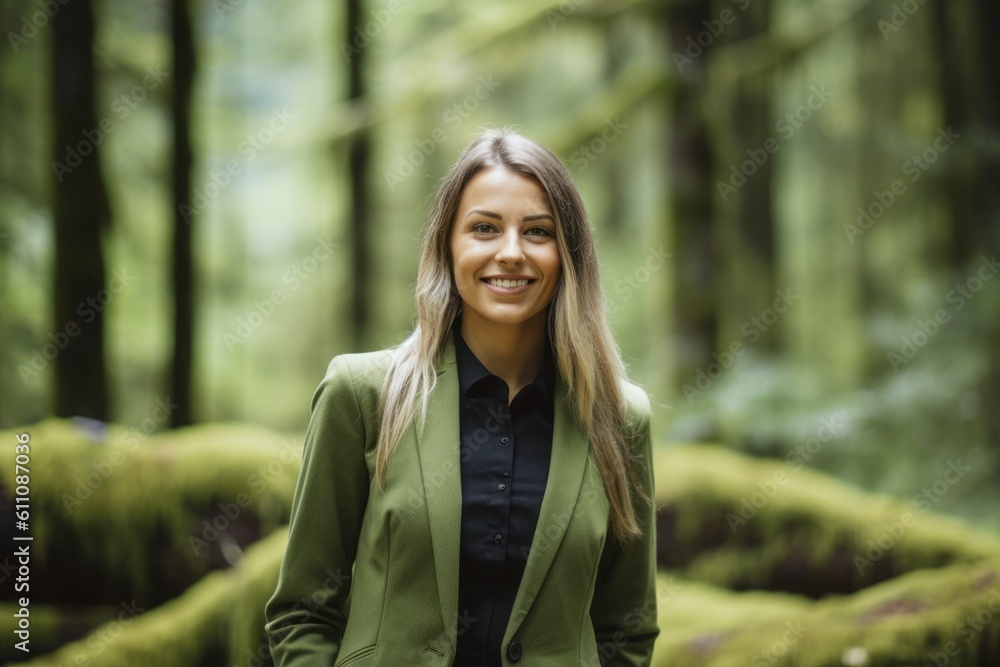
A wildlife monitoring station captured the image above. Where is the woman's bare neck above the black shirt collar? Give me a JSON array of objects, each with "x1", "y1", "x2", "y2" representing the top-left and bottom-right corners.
[{"x1": 461, "y1": 311, "x2": 546, "y2": 402}]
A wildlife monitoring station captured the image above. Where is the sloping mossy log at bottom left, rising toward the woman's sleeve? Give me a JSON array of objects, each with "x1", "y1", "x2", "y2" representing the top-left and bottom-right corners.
[{"x1": 5, "y1": 530, "x2": 288, "y2": 667}]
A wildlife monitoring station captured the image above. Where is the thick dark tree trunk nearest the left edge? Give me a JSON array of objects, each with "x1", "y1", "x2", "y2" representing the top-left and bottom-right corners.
[{"x1": 51, "y1": 0, "x2": 110, "y2": 420}]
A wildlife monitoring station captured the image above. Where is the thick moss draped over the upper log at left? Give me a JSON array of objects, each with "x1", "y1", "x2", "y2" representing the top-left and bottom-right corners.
[{"x1": 0, "y1": 420, "x2": 301, "y2": 598}]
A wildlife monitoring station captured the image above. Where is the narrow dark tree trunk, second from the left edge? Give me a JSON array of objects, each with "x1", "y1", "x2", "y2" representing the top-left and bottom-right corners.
[{"x1": 170, "y1": 0, "x2": 196, "y2": 427}]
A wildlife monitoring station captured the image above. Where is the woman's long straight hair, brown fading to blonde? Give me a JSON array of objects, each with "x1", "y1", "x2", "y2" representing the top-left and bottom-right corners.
[{"x1": 376, "y1": 130, "x2": 648, "y2": 542}]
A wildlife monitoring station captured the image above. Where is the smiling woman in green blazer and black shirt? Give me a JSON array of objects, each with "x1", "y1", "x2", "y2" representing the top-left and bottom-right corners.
[{"x1": 266, "y1": 130, "x2": 659, "y2": 667}]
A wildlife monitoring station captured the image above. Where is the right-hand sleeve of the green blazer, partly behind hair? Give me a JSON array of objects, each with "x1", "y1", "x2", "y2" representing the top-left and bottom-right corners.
[{"x1": 590, "y1": 398, "x2": 660, "y2": 667}]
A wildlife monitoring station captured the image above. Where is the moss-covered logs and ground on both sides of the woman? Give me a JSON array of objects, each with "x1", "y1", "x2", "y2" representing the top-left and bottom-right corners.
[{"x1": 0, "y1": 420, "x2": 1000, "y2": 667}]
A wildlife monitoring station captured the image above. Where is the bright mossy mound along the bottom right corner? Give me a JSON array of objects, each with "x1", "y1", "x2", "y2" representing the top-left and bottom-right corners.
[{"x1": 653, "y1": 559, "x2": 1000, "y2": 667}]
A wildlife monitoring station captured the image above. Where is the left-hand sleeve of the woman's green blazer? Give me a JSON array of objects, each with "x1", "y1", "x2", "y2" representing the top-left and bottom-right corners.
[{"x1": 264, "y1": 357, "x2": 369, "y2": 667}]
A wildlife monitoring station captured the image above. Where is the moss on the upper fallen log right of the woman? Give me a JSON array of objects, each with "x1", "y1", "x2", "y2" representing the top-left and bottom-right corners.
[{"x1": 655, "y1": 445, "x2": 1000, "y2": 591}]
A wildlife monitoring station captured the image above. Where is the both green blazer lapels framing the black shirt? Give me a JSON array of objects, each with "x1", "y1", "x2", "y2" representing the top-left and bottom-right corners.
[{"x1": 417, "y1": 336, "x2": 590, "y2": 644}]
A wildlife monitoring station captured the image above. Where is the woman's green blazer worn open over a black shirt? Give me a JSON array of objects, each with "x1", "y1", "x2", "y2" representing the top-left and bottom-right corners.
[{"x1": 265, "y1": 337, "x2": 659, "y2": 667}]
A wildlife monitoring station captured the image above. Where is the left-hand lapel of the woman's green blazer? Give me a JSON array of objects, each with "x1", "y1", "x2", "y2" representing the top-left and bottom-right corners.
[{"x1": 417, "y1": 336, "x2": 462, "y2": 631}]
